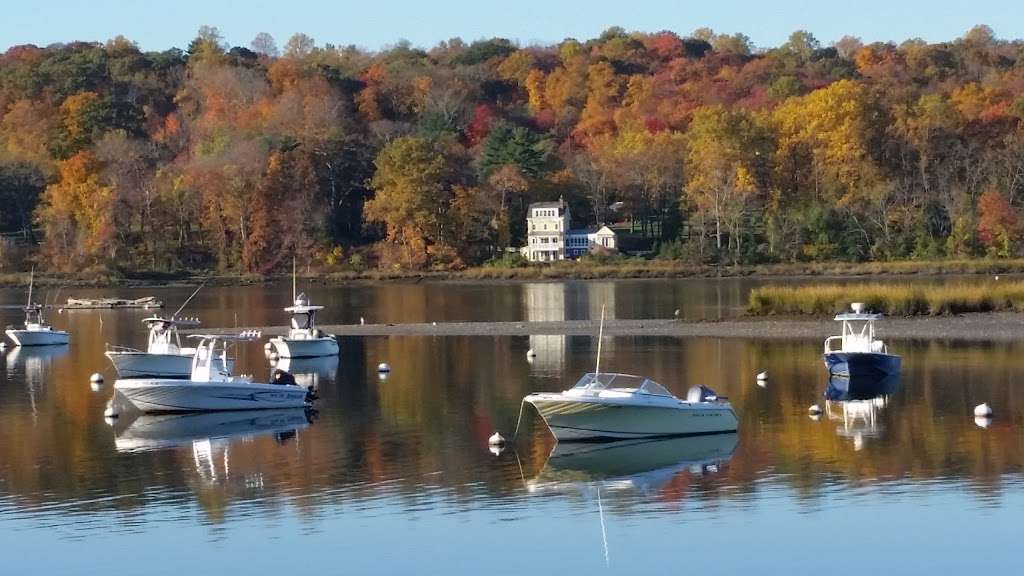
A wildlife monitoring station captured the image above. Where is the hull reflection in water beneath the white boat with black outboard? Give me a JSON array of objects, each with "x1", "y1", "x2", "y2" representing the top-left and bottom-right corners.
[{"x1": 114, "y1": 408, "x2": 311, "y2": 452}]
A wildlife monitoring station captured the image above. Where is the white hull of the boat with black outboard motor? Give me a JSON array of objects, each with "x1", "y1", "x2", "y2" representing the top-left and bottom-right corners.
[{"x1": 114, "y1": 378, "x2": 308, "y2": 412}]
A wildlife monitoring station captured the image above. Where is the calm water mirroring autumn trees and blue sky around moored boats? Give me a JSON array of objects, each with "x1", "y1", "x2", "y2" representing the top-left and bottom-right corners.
[{"x1": 0, "y1": 280, "x2": 1024, "y2": 574}]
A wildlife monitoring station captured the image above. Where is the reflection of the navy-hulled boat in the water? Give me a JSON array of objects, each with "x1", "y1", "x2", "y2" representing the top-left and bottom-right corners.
[{"x1": 825, "y1": 375, "x2": 901, "y2": 450}]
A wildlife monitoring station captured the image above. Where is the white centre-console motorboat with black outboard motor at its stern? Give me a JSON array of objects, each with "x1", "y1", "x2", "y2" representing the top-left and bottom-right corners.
[{"x1": 114, "y1": 332, "x2": 314, "y2": 412}]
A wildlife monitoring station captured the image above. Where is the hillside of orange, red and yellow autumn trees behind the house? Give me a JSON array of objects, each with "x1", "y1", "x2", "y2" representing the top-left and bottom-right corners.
[{"x1": 0, "y1": 27, "x2": 1024, "y2": 274}]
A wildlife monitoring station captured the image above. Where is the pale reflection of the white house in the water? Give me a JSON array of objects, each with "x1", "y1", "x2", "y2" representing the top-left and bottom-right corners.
[{"x1": 522, "y1": 282, "x2": 615, "y2": 374}]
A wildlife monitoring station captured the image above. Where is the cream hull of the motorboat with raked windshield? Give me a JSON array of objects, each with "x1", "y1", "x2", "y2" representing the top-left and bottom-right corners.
[{"x1": 525, "y1": 395, "x2": 737, "y2": 442}]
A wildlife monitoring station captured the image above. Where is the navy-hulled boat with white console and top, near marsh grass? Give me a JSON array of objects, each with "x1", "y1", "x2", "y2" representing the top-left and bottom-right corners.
[{"x1": 824, "y1": 302, "x2": 900, "y2": 379}]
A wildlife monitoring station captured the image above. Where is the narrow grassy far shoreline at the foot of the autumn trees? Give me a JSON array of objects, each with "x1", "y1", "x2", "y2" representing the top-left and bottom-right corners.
[{"x1": 0, "y1": 259, "x2": 1024, "y2": 287}]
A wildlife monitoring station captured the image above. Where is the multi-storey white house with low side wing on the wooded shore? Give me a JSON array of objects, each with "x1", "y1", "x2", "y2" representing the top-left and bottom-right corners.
[{"x1": 520, "y1": 200, "x2": 618, "y2": 262}]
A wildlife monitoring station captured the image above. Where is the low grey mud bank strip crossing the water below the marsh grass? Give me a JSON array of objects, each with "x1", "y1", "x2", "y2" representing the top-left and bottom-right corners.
[{"x1": 192, "y1": 313, "x2": 1024, "y2": 342}]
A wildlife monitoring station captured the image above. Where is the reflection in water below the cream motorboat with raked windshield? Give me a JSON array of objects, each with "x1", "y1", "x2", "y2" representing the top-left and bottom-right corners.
[{"x1": 526, "y1": 434, "x2": 737, "y2": 493}]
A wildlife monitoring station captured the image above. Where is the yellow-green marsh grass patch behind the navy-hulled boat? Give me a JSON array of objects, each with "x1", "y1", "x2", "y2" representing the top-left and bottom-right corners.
[{"x1": 748, "y1": 281, "x2": 1024, "y2": 316}]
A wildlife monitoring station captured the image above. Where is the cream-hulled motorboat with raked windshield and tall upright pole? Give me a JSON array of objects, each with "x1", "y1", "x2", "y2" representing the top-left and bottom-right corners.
[{"x1": 523, "y1": 308, "x2": 738, "y2": 441}]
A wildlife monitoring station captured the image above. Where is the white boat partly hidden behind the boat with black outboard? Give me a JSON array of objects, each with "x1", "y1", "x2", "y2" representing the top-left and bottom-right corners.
[{"x1": 103, "y1": 316, "x2": 234, "y2": 378}]
